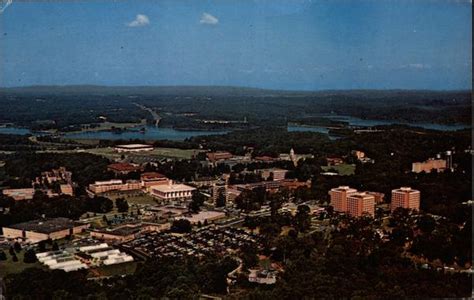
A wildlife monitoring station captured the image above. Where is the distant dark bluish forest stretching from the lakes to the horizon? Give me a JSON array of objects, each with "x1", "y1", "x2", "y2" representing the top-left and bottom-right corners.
[{"x1": 0, "y1": 86, "x2": 471, "y2": 131}]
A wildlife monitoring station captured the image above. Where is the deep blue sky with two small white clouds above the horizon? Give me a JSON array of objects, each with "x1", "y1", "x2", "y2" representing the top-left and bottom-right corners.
[{"x1": 0, "y1": 0, "x2": 472, "y2": 90}]
